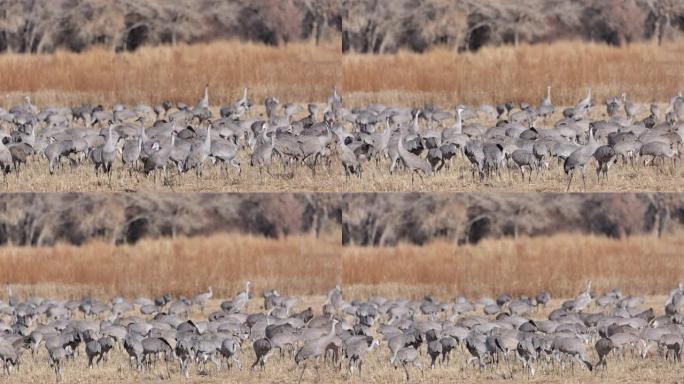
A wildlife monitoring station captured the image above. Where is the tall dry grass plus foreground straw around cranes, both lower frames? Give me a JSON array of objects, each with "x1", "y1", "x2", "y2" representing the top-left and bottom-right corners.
[{"x1": 0, "y1": 235, "x2": 684, "y2": 383}]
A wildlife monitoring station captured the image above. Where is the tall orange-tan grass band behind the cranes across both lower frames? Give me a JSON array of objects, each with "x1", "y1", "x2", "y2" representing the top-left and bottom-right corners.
[{"x1": 0, "y1": 233, "x2": 684, "y2": 300}]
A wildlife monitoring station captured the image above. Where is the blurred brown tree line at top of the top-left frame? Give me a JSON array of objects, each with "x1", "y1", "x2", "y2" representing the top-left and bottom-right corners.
[{"x1": 0, "y1": 0, "x2": 342, "y2": 53}]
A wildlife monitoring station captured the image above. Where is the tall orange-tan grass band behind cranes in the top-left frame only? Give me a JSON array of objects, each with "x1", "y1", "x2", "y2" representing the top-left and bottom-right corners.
[{"x1": 0, "y1": 41, "x2": 341, "y2": 107}]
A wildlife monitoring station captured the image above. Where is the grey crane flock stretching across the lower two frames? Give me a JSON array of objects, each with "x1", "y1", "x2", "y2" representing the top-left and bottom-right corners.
[{"x1": 0, "y1": 282, "x2": 684, "y2": 381}]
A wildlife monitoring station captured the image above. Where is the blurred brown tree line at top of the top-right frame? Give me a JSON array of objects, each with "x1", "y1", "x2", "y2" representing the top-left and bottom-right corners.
[{"x1": 342, "y1": 0, "x2": 684, "y2": 53}]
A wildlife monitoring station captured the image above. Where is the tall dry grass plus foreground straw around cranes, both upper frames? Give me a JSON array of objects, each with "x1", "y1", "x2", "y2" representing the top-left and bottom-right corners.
[{"x1": 0, "y1": 41, "x2": 684, "y2": 192}]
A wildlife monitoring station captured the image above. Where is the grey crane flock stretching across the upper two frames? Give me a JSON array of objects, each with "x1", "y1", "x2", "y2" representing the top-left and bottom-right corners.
[{"x1": 0, "y1": 85, "x2": 684, "y2": 190}]
